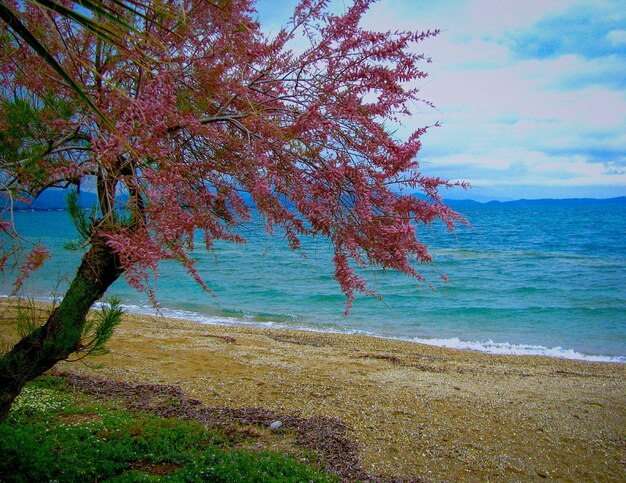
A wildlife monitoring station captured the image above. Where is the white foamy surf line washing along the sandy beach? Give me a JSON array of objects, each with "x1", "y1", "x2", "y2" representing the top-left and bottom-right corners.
[{"x1": 0, "y1": 295, "x2": 626, "y2": 364}]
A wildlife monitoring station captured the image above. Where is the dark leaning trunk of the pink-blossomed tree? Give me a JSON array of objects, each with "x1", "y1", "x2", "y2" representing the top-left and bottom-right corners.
[{"x1": 0, "y1": 237, "x2": 122, "y2": 422}]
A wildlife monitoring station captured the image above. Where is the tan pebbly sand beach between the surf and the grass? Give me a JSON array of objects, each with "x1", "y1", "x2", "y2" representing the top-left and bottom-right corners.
[{"x1": 0, "y1": 299, "x2": 626, "y2": 481}]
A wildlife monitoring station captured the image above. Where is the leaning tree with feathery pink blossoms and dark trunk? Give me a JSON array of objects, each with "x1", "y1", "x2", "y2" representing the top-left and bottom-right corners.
[{"x1": 0, "y1": 0, "x2": 460, "y2": 420}]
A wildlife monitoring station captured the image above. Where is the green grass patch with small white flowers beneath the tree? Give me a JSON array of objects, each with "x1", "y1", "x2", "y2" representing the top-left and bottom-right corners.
[{"x1": 0, "y1": 376, "x2": 335, "y2": 482}]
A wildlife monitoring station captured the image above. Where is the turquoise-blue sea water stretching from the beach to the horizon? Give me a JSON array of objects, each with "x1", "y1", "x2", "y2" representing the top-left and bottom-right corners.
[{"x1": 0, "y1": 204, "x2": 626, "y2": 362}]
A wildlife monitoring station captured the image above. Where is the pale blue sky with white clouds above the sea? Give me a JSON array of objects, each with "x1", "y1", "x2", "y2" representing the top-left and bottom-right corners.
[{"x1": 257, "y1": 0, "x2": 626, "y2": 200}]
